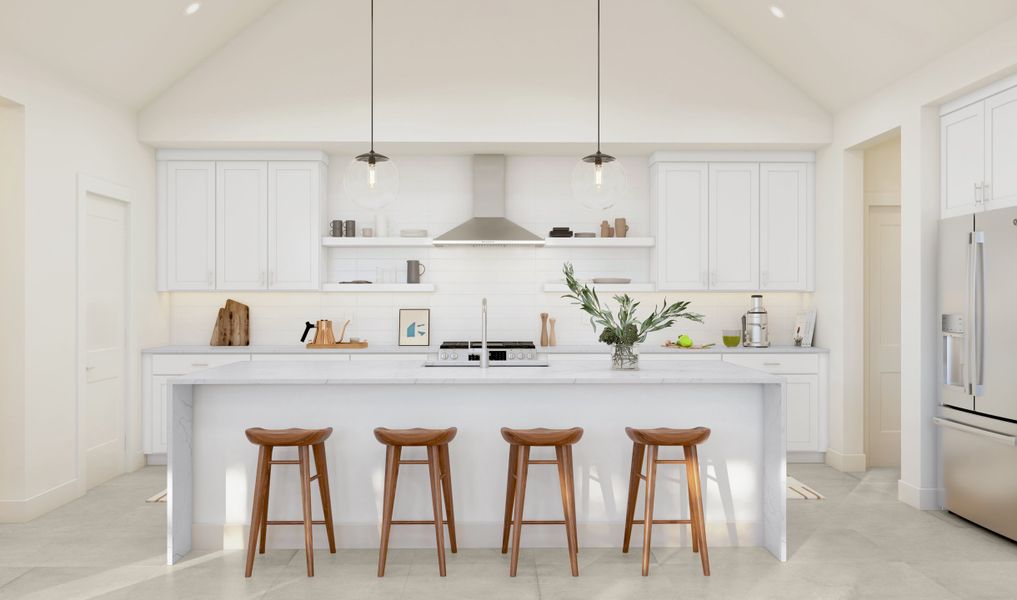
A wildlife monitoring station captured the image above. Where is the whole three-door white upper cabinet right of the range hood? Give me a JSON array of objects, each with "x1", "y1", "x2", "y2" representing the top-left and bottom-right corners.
[{"x1": 650, "y1": 152, "x2": 816, "y2": 291}]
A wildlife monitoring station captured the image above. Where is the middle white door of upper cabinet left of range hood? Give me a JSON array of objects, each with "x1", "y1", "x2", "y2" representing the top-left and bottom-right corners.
[{"x1": 216, "y1": 161, "x2": 268, "y2": 290}]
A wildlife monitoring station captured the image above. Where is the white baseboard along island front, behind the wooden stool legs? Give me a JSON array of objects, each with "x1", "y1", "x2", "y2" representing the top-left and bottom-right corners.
[{"x1": 191, "y1": 521, "x2": 763, "y2": 550}]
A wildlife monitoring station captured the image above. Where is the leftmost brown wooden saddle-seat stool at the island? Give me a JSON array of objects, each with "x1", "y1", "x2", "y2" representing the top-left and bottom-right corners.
[{"x1": 244, "y1": 427, "x2": 336, "y2": 577}]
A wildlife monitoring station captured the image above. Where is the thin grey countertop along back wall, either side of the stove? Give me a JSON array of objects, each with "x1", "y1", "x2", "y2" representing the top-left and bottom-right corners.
[{"x1": 141, "y1": 344, "x2": 830, "y2": 355}]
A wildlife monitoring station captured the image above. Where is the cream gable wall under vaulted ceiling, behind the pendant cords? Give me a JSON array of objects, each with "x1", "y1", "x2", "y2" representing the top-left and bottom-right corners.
[{"x1": 140, "y1": 0, "x2": 830, "y2": 152}]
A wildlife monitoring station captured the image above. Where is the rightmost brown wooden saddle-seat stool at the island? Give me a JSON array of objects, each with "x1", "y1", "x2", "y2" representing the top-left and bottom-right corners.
[{"x1": 621, "y1": 427, "x2": 710, "y2": 577}]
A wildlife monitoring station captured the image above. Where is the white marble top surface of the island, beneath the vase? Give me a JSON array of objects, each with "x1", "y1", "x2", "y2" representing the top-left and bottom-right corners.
[{"x1": 171, "y1": 360, "x2": 784, "y2": 385}]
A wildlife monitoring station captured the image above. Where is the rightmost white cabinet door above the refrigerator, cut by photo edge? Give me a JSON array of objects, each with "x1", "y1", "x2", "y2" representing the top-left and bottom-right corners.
[{"x1": 985, "y1": 87, "x2": 1017, "y2": 211}]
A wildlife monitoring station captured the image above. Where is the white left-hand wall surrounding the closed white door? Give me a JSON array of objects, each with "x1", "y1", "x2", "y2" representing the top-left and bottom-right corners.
[{"x1": 0, "y1": 53, "x2": 167, "y2": 521}]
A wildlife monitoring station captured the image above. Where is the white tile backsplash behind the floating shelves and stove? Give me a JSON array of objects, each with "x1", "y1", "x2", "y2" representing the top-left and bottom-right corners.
[{"x1": 171, "y1": 155, "x2": 812, "y2": 346}]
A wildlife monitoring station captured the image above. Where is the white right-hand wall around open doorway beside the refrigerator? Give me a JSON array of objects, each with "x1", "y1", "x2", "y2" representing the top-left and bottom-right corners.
[{"x1": 816, "y1": 12, "x2": 1017, "y2": 507}]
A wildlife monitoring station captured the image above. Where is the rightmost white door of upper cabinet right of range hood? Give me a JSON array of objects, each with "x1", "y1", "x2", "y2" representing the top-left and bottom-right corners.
[{"x1": 760, "y1": 163, "x2": 814, "y2": 291}]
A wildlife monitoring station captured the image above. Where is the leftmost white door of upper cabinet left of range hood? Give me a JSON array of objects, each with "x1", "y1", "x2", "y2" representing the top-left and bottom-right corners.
[{"x1": 159, "y1": 161, "x2": 216, "y2": 290}]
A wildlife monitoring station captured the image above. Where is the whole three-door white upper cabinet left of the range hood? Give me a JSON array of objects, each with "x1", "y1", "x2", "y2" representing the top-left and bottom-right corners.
[{"x1": 157, "y1": 151, "x2": 327, "y2": 291}]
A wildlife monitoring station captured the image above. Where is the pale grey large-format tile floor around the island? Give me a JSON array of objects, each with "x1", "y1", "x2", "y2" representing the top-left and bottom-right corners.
[{"x1": 0, "y1": 465, "x2": 1017, "y2": 600}]
